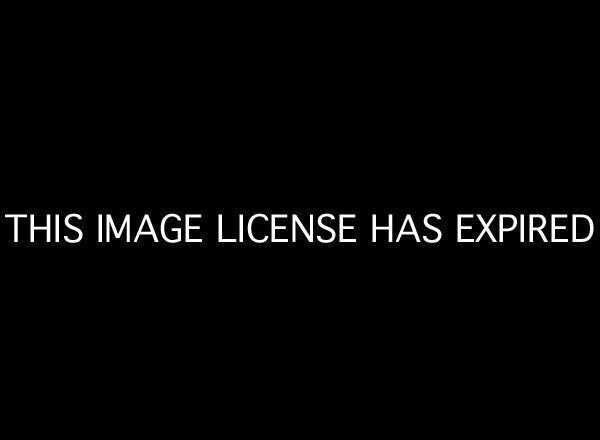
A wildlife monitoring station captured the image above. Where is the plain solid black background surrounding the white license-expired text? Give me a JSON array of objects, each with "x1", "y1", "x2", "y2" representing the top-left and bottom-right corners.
[{"x1": 1, "y1": 5, "x2": 598, "y2": 433}]
